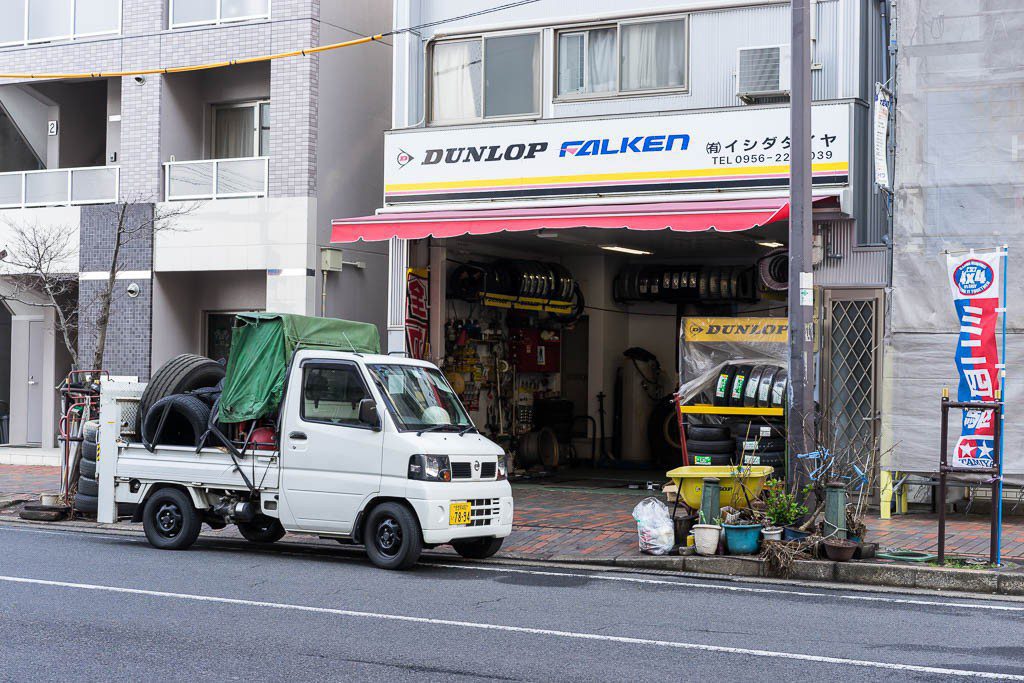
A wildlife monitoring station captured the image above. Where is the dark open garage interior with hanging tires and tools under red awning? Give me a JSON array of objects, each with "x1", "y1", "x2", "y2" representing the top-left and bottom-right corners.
[{"x1": 410, "y1": 220, "x2": 787, "y2": 489}]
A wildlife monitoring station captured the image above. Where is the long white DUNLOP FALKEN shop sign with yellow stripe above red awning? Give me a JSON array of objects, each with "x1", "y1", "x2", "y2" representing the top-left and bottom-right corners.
[{"x1": 384, "y1": 104, "x2": 852, "y2": 205}]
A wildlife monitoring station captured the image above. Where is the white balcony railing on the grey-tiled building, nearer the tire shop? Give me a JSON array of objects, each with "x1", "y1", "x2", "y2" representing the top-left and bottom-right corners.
[{"x1": 164, "y1": 157, "x2": 270, "y2": 202}]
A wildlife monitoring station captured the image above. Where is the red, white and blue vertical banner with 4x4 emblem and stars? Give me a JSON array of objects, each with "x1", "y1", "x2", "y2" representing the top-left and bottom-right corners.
[{"x1": 946, "y1": 251, "x2": 1001, "y2": 468}]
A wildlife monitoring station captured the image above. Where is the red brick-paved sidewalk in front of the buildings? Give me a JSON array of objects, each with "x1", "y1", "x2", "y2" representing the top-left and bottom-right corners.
[{"x1": 0, "y1": 465, "x2": 1024, "y2": 562}]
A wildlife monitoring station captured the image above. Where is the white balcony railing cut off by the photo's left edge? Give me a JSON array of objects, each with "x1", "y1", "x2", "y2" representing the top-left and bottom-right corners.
[{"x1": 0, "y1": 166, "x2": 121, "y2": 209}]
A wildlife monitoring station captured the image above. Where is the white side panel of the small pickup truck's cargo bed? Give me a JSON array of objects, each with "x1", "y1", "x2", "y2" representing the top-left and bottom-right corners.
[{"x1": 115, "y1": 443, "x2": 280, "y2": 489}]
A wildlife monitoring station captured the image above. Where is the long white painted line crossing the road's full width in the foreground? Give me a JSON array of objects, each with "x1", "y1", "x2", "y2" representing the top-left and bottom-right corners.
[{"x1": 0, "y1": 575, "x2": 1024, "y2": 681}]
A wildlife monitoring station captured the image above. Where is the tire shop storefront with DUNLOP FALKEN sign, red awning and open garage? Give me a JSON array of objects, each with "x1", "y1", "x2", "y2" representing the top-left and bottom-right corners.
[{"x1": 333, "y1": 103, "x2": 852, "y2": 487}]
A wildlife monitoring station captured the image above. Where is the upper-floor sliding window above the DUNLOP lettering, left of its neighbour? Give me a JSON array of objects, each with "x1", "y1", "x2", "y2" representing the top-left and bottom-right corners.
[{"x1": 430, "y1": 33, "x2": 541, "y2": 123}]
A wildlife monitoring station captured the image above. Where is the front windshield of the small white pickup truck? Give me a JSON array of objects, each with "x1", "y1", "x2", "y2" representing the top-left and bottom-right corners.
[{"x1": 370, "y1": 364, "x2": 473, "y2": 431}]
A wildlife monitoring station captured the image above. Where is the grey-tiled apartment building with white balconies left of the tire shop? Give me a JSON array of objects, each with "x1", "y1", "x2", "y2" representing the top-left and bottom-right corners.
[{"x1": 0, "y1": 0, "x2": 391, "y2": 443}]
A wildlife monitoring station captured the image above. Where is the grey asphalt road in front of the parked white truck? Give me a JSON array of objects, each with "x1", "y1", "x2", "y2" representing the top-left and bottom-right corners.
[{"x1": 0, "y1": 525, "x2": 1024, "y2": 681}]
